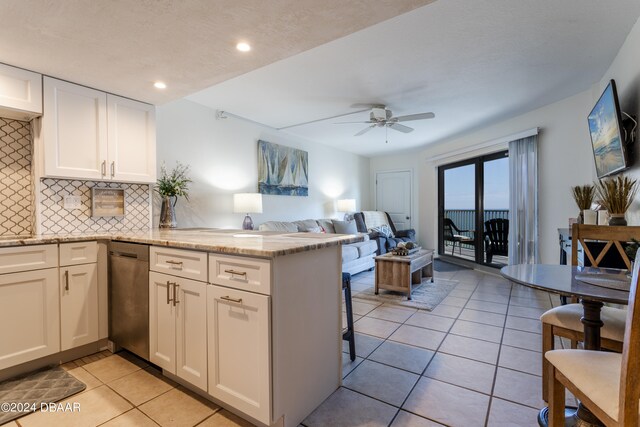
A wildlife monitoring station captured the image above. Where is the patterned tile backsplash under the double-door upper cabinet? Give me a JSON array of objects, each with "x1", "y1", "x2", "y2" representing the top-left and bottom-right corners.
[{"x1": 40, "y1": 178, "x2": 151, "y2": 234}]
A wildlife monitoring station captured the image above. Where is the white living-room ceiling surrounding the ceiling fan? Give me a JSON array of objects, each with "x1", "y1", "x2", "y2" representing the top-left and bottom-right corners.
[{"x1": 187, "y1": 0, "x2": 640, "y2": 156}]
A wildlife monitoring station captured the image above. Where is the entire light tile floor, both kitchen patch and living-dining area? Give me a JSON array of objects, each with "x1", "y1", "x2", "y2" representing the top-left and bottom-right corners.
[{"x1": 7, "y1": 264, "x2": 575, "y2": 427}]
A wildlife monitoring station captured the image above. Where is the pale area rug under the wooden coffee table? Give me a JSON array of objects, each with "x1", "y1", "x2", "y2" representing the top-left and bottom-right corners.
[{"x1": 353, "y1": 278, "x2": 458, "y2": 311}]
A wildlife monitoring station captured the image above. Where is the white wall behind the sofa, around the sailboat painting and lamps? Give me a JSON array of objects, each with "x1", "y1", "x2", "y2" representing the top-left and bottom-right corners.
[{"x1": 154, "y1": 100, "x2": 369, "y2": 228}]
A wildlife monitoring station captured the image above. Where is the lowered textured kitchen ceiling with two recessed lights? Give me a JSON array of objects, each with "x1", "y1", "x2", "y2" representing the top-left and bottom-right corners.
[{"x1": 0, "y1": 0, "x2": 433, "y2": 104}]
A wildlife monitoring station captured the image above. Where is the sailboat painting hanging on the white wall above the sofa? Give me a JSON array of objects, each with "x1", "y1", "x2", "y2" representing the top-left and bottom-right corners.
[{"x1": 258, "y1": 141, "x2": 309, "y2": 196}]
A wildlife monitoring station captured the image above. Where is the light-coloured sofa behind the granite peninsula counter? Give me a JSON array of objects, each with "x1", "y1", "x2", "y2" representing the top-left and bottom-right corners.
[{"x1": 259, "y1": 219, "x2": 378, "y2": 274}]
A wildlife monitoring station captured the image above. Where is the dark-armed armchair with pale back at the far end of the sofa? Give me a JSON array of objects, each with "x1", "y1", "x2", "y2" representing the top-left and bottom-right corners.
[{"x1": 353, "y1": 211, "x2": 416, "y2": 255}]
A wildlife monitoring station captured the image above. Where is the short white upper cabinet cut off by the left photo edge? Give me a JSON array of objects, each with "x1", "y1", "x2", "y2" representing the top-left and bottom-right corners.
[{"x1": 0, "y1": 64, "x2": 42, "y2": 120}]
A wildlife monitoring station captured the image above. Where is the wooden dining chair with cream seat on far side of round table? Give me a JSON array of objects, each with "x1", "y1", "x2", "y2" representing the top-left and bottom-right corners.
[{"x1": 540, "y1": 224, "x2": 640, "y2": 402}]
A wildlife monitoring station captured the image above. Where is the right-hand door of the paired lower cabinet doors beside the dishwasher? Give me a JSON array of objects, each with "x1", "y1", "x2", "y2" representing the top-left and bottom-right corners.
[{"x1": 174, "y1": 277, "x2": 207, "y2": 391}]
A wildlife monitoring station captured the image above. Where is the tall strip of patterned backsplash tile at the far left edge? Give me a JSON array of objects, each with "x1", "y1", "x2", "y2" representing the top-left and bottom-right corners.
[{"x1": 0, "y1": 118, "x2": 34, "y2": 236}]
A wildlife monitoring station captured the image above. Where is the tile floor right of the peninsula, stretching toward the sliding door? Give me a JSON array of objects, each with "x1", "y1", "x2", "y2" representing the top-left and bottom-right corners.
[{"x1": 302, "y1": 264, "x2": 575, "y2": 427}]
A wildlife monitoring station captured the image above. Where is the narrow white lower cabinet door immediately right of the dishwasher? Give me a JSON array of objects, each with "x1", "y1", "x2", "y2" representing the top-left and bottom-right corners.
[{"x1": 149, "y1": 271, "x2": 177, "y2": 374}]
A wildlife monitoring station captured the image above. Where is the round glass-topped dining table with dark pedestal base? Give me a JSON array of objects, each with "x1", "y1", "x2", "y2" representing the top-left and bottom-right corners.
[{"x1": 500, "y1": 264, "x2": 630, "y2": 425}]
